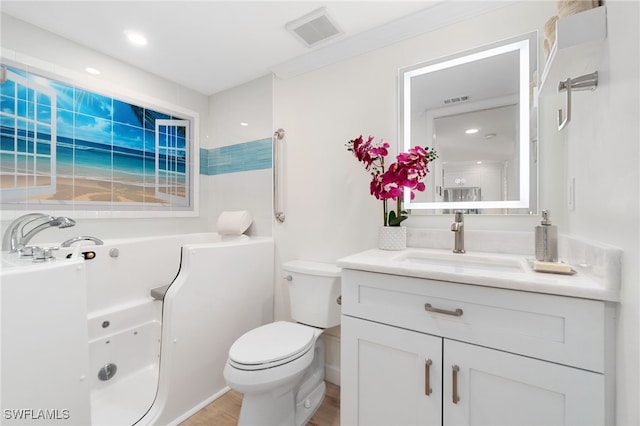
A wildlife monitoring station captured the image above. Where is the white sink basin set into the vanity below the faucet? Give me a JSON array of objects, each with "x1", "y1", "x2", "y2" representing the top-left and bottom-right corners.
[{"x1": 392, "y1": 250, "x2": 525, "y2": 272}]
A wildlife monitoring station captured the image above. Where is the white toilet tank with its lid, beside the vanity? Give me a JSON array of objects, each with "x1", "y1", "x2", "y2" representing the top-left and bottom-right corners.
[{"x1": 282, "y1": 260, "x2": 341, "y2": 328}]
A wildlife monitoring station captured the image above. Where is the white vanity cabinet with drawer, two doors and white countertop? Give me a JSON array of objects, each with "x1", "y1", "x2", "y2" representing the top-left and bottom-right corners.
[{"x1": 338, "y1": 245, "x2": 619, "y2": 426}]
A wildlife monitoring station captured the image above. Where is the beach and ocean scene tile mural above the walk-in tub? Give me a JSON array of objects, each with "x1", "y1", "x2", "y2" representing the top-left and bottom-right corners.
[{"x1": 0, "y1": 65, "x2": 193, "y2": 210}]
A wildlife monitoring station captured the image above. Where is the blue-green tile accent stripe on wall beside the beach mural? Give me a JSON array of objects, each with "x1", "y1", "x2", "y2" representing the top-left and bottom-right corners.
[{"x1": 200, "y1": 138, "x2": 272, "y2": 175}]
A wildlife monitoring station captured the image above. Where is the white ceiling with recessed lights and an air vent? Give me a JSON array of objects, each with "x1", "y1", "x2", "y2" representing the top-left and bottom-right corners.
[{"x1": 0, "y1": 0, "x2": 510, "y2": 95}]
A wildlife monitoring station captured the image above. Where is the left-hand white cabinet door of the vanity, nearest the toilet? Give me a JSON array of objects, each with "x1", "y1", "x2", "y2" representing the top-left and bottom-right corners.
[{"x1": 341, "y1": 315, "x2": 442, "y2": 426}]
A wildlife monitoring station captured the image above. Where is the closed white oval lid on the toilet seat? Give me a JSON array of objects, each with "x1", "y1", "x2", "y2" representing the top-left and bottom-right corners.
[{"x1": 229, "y1": 321, "x2": 314, "y2": 369}]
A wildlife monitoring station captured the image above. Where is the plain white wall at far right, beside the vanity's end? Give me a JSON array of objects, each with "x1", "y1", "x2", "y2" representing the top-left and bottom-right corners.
[{"x1": 564, "y1": 1, "x2": 640, "y2": 425}]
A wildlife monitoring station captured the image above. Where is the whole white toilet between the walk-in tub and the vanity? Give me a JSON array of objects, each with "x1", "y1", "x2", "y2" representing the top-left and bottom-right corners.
[{"x1": 224, "y1": 260, "x2": 341, "y2": 426}]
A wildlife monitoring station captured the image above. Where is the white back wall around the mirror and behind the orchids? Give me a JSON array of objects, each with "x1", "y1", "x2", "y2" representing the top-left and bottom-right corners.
[{"x1": 274, "y1": 2, "x2": 555, "y2": 272}]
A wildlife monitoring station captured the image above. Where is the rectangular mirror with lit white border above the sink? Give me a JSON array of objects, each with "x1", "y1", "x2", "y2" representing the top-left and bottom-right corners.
[{"x1": 398, "y1": 32, "x2": 538, "y2": 214}]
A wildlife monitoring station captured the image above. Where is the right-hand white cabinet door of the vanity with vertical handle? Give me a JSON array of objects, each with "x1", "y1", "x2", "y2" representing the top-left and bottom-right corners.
[{"x1": 443, "y1": 339, "x2": 605, "y2": 426}]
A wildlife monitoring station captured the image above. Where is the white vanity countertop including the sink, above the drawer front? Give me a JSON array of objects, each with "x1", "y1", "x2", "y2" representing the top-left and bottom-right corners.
[{"x1": 337, "y1": 248, "x2": 620, "y2": 302}]
